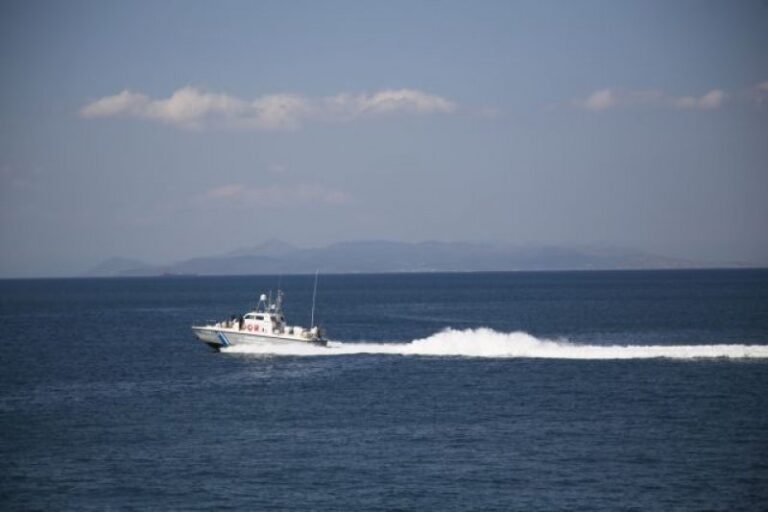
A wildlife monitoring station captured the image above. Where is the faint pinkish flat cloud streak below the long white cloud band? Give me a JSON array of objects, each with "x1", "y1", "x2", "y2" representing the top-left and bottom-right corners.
[{"x1": 204, "y1": 183, "x2": 349, "y2": 206}]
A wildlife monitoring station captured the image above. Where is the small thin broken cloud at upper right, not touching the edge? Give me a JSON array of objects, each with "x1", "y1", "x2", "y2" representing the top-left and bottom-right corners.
[{"x1": 570, "y1": 89, "x2": 727, "y2": 112}]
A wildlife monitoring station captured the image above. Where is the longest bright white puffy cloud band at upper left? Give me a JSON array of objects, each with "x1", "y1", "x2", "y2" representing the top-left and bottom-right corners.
[{"x1": 80, "y1": 86, "x2": 457, "y2": 130}]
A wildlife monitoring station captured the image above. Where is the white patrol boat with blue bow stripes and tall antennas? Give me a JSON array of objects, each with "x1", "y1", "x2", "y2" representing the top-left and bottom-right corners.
[{"x1": 192, "y1": 290, "x2": 328, "y2": 351}]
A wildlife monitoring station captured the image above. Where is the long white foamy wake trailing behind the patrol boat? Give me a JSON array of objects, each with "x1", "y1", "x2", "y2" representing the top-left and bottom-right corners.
[{"x1": 223, "y1": 328, "x2": 768, "y2": 359}]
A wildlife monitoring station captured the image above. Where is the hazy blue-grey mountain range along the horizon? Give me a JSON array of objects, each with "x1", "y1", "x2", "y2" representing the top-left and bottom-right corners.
[{"x1": 84, "y1": 240, "x2": 740, "y2": 277}]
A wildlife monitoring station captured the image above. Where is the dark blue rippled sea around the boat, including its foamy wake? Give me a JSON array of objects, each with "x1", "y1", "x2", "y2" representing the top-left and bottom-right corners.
[{"x1": 0, "y1": 270, "x2": 768, "y2": 511}]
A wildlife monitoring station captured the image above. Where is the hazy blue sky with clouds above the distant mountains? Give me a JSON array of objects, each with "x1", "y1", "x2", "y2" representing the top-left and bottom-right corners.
[{"x1": 0, "y1": 1, "x2": 768, "y2": 276}]
